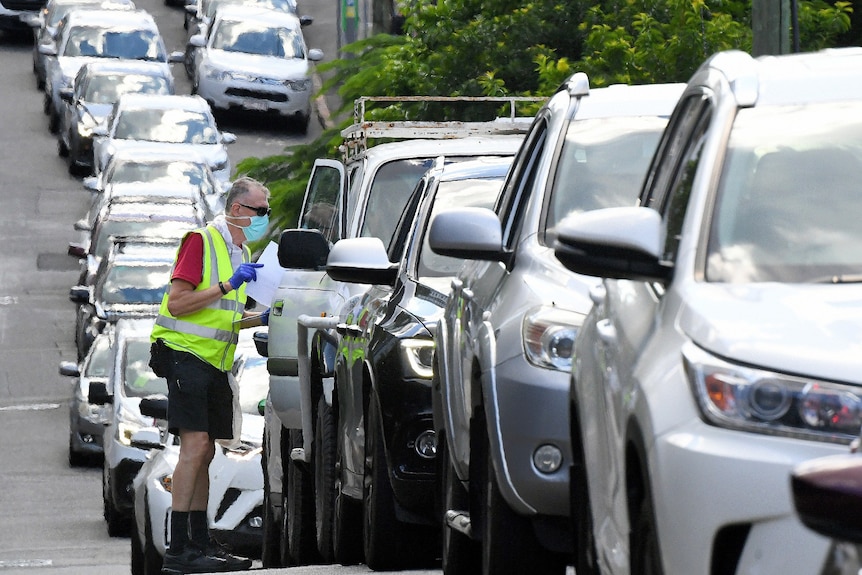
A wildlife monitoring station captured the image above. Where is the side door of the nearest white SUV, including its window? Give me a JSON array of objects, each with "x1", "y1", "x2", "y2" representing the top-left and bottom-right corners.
[{"x1": 588, "y1": 91, "x2": 712, "y2": 555}]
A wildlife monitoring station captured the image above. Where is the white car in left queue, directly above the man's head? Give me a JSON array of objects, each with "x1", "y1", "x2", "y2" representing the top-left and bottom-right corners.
[{"x1": 93, "y1": 94, "x2": 236, "y2": 182}]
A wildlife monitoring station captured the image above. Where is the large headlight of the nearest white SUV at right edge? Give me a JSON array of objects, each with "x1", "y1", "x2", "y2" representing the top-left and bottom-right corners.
[{"x1": 682, "y1": 343, "x2": 862, "y2": 443}]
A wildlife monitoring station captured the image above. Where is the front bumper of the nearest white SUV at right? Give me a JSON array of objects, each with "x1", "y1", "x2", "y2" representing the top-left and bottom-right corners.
[{"x1": 648, "y1": 419, "x2": 847, "y2": 575}]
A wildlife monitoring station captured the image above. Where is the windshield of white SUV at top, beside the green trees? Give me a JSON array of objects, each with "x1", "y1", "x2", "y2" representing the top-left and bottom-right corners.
[{"x1": 211, "y1": 20, "x2": 305, "y2": 58}]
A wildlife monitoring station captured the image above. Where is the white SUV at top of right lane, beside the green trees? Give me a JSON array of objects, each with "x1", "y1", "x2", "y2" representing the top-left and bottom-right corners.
[{"x1": 188, "y1": 5, "x2": 323, "y2": 132}]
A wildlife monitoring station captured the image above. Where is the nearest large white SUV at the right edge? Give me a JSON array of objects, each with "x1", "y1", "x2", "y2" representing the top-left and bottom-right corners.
[{"x1": 556, "y1": 48, "x2": 862, "y2": 575}]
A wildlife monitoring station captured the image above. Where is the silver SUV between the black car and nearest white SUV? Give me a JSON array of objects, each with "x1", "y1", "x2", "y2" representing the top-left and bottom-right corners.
[{"x1": 430, "y1": 73, "x2": 684, "y2": 575}]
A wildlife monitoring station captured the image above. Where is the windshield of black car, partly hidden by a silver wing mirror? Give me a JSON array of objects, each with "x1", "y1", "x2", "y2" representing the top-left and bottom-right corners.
[{"x1": 416, "y1": 174, "x2": 505, "y2": 278}]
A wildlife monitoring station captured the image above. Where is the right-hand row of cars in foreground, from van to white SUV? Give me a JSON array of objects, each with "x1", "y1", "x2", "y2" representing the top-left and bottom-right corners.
[{"x1": 251, "y1": 49, "x2": 862, "y2": 575}]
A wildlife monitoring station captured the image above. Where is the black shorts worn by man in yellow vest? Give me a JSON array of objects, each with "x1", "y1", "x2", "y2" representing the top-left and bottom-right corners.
[{"x1": 167, "y1": 350, "x2": 233, "y2": 439}]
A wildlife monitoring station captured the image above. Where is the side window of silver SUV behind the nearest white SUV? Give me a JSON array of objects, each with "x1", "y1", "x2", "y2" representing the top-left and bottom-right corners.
[{"x1": 496, "y1": 116, "x2": 548, "y2": 249}]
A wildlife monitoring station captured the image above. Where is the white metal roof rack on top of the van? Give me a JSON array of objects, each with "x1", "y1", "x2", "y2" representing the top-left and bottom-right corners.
[{"x1": 341, "y1": 96, "x2": 547, "y2": 159}]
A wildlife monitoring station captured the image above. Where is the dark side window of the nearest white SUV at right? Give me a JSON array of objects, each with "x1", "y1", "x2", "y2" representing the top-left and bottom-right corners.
[{"x1": 643, "y1": 94, "x2": 711, "y2": 262}]
